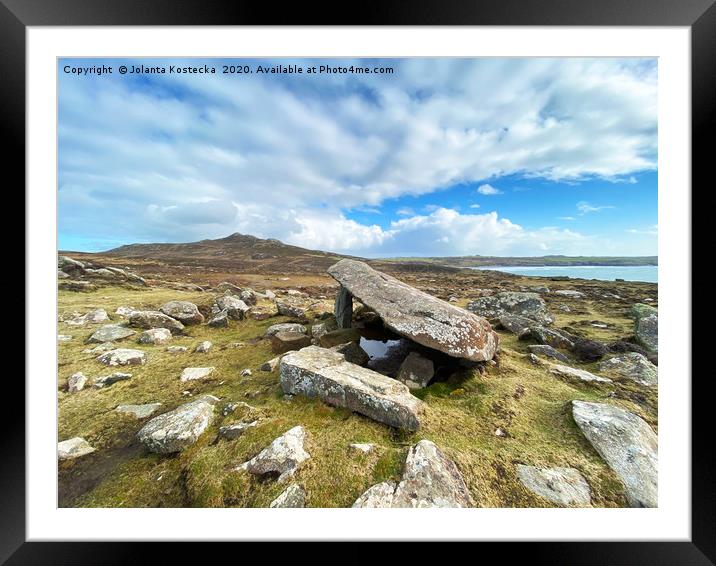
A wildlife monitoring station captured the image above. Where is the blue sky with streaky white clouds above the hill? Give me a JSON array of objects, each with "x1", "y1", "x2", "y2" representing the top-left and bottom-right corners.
[{"x1": 58, "y1": 58, "x2": 658, "y2": 257}]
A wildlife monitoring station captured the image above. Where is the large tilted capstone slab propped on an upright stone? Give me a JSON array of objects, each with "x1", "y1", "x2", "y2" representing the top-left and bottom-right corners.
[{"x1": 328, "y1": 259, "x2": 499, "y2": 362}]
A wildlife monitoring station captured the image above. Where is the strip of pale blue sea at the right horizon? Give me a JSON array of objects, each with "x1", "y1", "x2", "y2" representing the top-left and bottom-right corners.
[{"x1": 471, "y1": 265, "x2": 659, "y2": 283}]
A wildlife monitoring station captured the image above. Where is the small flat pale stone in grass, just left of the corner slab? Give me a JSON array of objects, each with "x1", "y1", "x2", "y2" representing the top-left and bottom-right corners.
[{"x1": 517, "y1": 464, "x2": 592, "y2": 507}]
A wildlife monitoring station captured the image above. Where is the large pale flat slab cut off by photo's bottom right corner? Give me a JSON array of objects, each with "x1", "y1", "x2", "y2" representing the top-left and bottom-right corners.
[{"x1": 572, "y1": 401, "x2": 659, "y2": 507}]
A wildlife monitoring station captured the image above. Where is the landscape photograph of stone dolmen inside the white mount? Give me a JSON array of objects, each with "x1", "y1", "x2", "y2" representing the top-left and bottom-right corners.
[{"x1": 56, "y1": 56, "x2": 660, "y2": 518}]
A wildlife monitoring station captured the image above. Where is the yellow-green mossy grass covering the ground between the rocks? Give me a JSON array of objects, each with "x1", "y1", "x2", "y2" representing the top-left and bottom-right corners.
[{"x1": 58, "y1": 287, "x2": 658, "y2": 507}]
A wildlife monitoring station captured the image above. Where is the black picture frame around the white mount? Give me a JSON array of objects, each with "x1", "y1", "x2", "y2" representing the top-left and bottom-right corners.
[{"x1": 7, "y1": 0, "x2": 716, "y2": 565}]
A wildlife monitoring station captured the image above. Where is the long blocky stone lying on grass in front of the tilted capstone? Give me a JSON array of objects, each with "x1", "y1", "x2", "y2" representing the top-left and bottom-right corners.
[{"x1": 280, "y1": 346, "x2": 422, "y2": 430}]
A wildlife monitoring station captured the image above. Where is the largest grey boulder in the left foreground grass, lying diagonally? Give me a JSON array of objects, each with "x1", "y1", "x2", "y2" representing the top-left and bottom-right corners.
[{"x1": 137, "y1": 395, "x2": 218, "y2": 454}]
